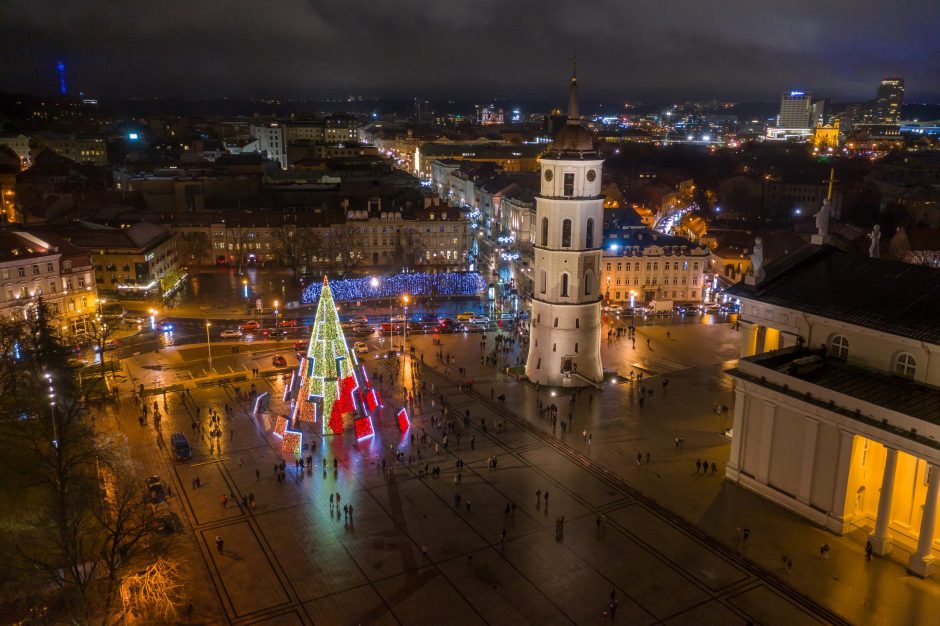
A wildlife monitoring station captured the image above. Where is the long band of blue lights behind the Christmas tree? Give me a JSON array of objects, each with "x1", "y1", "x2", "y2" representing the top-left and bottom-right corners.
[{"x1": 300, "y1": 272, "x2": 486, "y2": 304}]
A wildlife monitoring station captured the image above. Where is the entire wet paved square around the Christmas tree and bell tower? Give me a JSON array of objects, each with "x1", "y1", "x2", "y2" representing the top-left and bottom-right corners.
[{"x1": 104, "y1": 314, "x2": 938, "y2": 625}]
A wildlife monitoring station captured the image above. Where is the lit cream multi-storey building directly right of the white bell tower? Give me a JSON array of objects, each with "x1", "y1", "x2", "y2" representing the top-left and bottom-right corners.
[{"x1": 601, "y1": 228, "x2": 710, "y2": 304}]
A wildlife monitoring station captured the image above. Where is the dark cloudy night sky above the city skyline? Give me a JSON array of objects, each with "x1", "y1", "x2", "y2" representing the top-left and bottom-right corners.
[{"x1": 0, "y1": 0, "x2": 940, "y2": 101}]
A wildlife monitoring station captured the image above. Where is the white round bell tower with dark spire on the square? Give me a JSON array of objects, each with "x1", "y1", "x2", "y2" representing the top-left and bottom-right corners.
[{"x1": 525, "y1": 77, "x2": 604, "y2": 387}]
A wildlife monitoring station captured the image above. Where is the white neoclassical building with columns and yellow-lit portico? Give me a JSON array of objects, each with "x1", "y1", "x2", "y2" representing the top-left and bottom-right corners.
[{"x1": 726, "y1": 245, "x2": 940, "y2": 576}]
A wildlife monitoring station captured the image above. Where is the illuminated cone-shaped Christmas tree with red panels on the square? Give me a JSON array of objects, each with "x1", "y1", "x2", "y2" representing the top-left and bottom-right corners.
[{"x1": 294, "y1": 276, "x2": 371, "y2": 435}]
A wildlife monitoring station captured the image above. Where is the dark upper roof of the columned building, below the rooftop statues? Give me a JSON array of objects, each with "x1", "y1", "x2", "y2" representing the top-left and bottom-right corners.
[{"x1": 726, "y1": 246, "x2": 940, "y2": 345}]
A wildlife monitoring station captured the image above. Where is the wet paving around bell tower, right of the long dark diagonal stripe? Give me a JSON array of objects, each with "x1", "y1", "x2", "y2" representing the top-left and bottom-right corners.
[{"x1": 410, "y1": 326, "x2": 940, "y2": 624}]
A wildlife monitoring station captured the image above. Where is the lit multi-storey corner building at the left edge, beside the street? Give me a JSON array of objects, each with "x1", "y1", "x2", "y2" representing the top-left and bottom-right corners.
[{"x1": 0, "y1": 230, "x2": 98, "y2": 337}]
